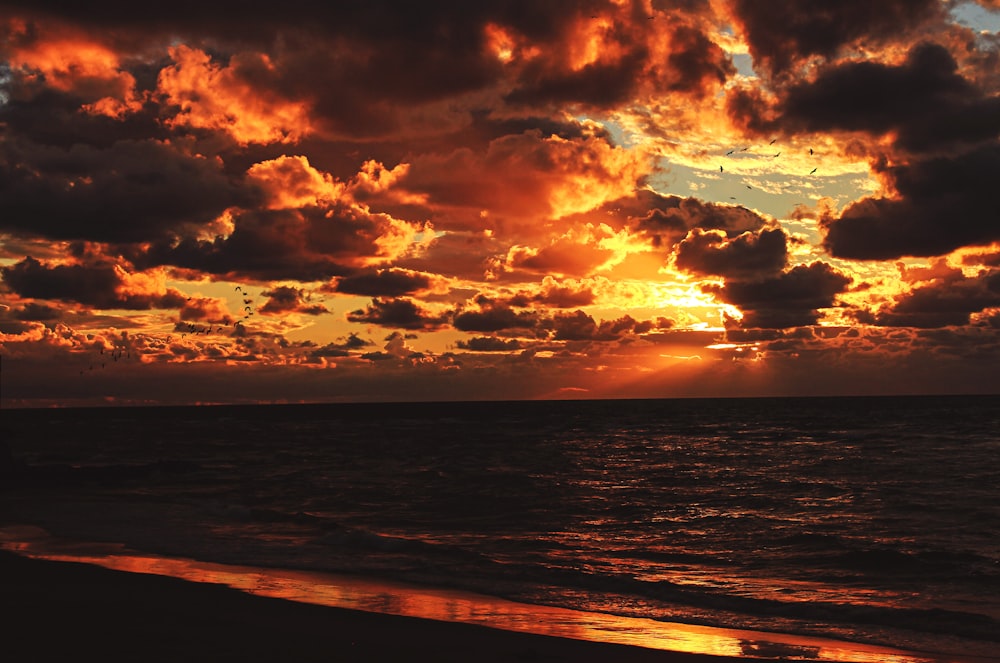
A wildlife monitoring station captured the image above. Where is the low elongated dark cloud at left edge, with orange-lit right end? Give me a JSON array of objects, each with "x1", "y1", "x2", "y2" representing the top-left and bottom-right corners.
[{"x1": 0, "y1": 256, "x2": 185, "y2": 310}]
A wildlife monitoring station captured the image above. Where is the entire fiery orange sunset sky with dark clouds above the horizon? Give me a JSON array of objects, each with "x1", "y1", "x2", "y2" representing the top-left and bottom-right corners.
[{"x1": 0, "y1": 0, "x2": 1000, "y2": 407}]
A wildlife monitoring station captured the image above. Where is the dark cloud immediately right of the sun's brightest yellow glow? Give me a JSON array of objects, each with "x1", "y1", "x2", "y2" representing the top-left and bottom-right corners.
[{"x1": 702, "y1": 262, "x2": 851, "y2": 329}]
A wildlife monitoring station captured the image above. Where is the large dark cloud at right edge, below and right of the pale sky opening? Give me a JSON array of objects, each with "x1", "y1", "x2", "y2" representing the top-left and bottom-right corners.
[{"x1": 821, "y1": 143, "x2": 1000, "y2": 260}]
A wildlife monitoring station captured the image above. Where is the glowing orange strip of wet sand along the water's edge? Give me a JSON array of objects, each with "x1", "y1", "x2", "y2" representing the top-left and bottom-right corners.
[{"x1": 0, "y1": 527, "x2": 956, "y2": 663}]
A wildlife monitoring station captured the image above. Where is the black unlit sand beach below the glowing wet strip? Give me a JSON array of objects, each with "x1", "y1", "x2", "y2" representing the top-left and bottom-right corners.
[{"x1": 0, "y1": 551, "x2": 738, "y2": 663}]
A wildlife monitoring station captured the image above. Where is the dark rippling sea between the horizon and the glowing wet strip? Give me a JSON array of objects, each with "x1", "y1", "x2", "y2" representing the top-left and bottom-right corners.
[{"x1": 0, "y1": 396, "x2": 1000, "y2": 656}]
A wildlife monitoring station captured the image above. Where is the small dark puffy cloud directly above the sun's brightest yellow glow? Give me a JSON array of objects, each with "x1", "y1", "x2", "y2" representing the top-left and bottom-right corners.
[{"x1": 676, "y1": 228, "x2": 788, "y2": 278}]
